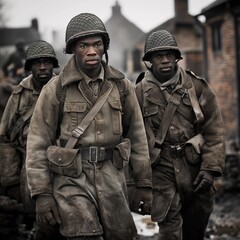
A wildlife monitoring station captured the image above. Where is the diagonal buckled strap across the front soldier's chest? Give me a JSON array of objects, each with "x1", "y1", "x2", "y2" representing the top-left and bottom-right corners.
[{"x1": 65, "y1": 84, "x2": 112, "y2": 148}]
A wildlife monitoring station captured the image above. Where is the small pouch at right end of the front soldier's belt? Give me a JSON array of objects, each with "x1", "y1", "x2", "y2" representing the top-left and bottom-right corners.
[{"x1": 113, "y1": 138, "x2": 131, "y2": 169}]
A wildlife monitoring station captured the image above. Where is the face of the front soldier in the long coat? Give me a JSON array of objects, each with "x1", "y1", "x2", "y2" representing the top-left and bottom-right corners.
[{"x1": 73, "y1": 36, "x2": 104, "y2": 75}]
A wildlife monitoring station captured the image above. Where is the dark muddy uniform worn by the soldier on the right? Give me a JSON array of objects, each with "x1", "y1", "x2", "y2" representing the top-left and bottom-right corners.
[{"x1": 136, "y1": 68, "x2": 224, "y2": 239}]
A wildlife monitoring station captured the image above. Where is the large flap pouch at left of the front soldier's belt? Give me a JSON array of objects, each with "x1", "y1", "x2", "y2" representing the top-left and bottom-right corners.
[{"x1": 47, "y1": 146, "x2": 82, "y2": 178}]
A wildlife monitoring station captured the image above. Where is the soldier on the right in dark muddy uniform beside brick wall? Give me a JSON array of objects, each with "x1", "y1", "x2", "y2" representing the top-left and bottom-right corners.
[{"x1": 136, "y1": 30, "x2": 224, "y2": 240}]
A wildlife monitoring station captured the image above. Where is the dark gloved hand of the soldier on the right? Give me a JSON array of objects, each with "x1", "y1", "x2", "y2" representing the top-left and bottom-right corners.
[{"x1": 193, "y1": 170, "x2": 214, "y2": 193}]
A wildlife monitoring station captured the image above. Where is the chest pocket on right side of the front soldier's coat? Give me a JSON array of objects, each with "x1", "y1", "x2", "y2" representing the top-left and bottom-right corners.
[{"x1": 109, "y1": 100, "x2": 122, "y2": 135}]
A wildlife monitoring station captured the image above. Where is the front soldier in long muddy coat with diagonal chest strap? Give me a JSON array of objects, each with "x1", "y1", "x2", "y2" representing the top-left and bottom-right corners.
[{"x1": 26, "y1": 13, "x2": 152, "y2": 240}]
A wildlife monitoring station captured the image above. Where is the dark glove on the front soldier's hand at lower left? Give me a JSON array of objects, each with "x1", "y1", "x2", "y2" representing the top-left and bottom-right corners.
[{"x1": 36, "y1": 194, "x2": 61, "y2": 225}]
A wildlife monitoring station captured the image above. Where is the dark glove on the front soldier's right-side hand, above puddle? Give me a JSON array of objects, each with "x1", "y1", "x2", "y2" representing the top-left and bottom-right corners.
[{"x1": 132, "y1": 187, "x2": 152, "y2": 215}]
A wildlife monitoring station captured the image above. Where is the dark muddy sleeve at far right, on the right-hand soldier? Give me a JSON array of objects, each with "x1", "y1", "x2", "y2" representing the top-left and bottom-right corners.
[{"x1": 199, "y1": 81, "x2": 225, "y2": 176}]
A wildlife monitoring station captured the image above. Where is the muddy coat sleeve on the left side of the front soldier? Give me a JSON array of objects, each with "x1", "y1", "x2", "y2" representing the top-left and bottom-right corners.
[{"x1": 26, "y1": 82, "x2": 59, "y2": 197}]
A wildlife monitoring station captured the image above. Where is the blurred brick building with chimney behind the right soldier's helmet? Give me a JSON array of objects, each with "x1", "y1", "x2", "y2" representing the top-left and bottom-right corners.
[{"x1": 126, "y1": 0, "x2": 203, "y2": 80}]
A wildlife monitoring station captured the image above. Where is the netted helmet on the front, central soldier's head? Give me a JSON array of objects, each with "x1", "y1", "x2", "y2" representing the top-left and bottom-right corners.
[{"x1": 65, "y1": 13, "x2": 110, "y2": 54}]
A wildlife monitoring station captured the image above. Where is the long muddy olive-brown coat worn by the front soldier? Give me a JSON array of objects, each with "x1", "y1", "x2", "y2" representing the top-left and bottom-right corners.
[{"x1": 26, "y1": 57, "x2": 152, "y2": 240}]
